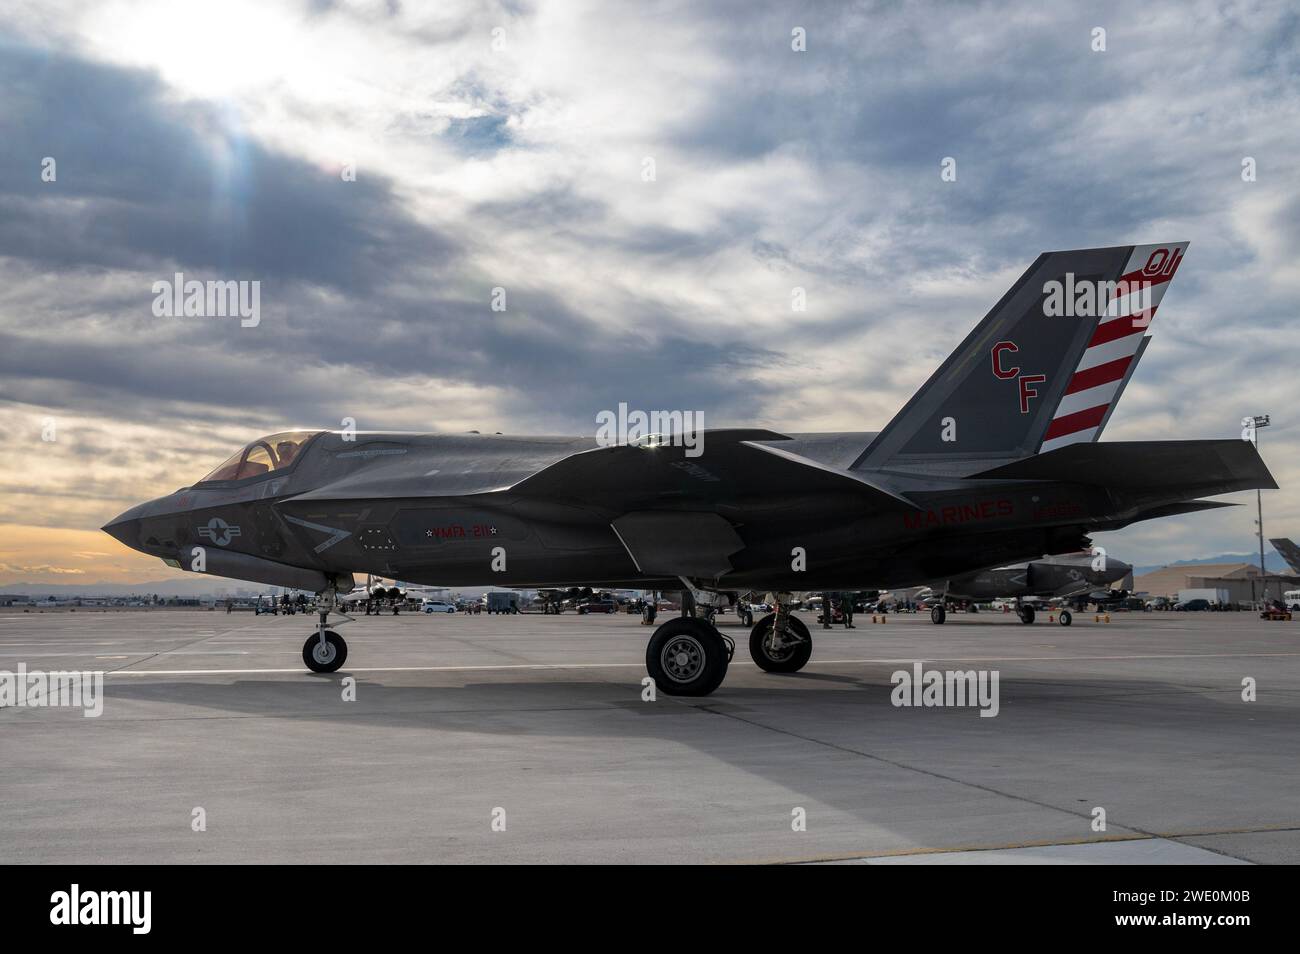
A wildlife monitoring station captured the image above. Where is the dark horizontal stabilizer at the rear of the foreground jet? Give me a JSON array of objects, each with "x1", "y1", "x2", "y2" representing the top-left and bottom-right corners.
[{"x1": 967, "y1": 439, "x2": 1278, "y2": 496}]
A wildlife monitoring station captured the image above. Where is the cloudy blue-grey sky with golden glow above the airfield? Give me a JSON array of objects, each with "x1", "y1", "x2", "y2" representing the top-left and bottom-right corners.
[{"x1": 0, "y1": 0, "x2": 1300, "y2": 585}]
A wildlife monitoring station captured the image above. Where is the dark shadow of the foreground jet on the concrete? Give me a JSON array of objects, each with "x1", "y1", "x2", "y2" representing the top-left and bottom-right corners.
[{"x1": 94, "y1": 664, "x2": 1300, "y2": 863}]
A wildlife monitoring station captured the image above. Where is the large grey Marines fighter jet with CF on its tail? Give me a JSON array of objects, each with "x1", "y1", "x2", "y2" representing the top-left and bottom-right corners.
[{"x1": 104, "y1": 243, "x2": 1277, "y2": 695}]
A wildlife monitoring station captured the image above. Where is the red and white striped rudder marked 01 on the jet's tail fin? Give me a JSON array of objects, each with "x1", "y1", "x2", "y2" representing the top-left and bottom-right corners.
[{"x1": 1040, "y1": 242, "x2": 1188, "y2": 452}]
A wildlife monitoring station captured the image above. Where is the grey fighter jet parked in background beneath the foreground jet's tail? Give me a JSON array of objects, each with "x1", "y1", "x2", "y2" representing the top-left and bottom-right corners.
[{"x1": 930, "y1": 551, "x2": 1132, "y2": 626}]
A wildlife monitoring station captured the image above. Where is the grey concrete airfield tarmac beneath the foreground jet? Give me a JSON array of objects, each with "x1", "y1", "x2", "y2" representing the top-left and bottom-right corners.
[{"x1": 0, "y1": 610, "x2": 1300, "y2": 864}]
